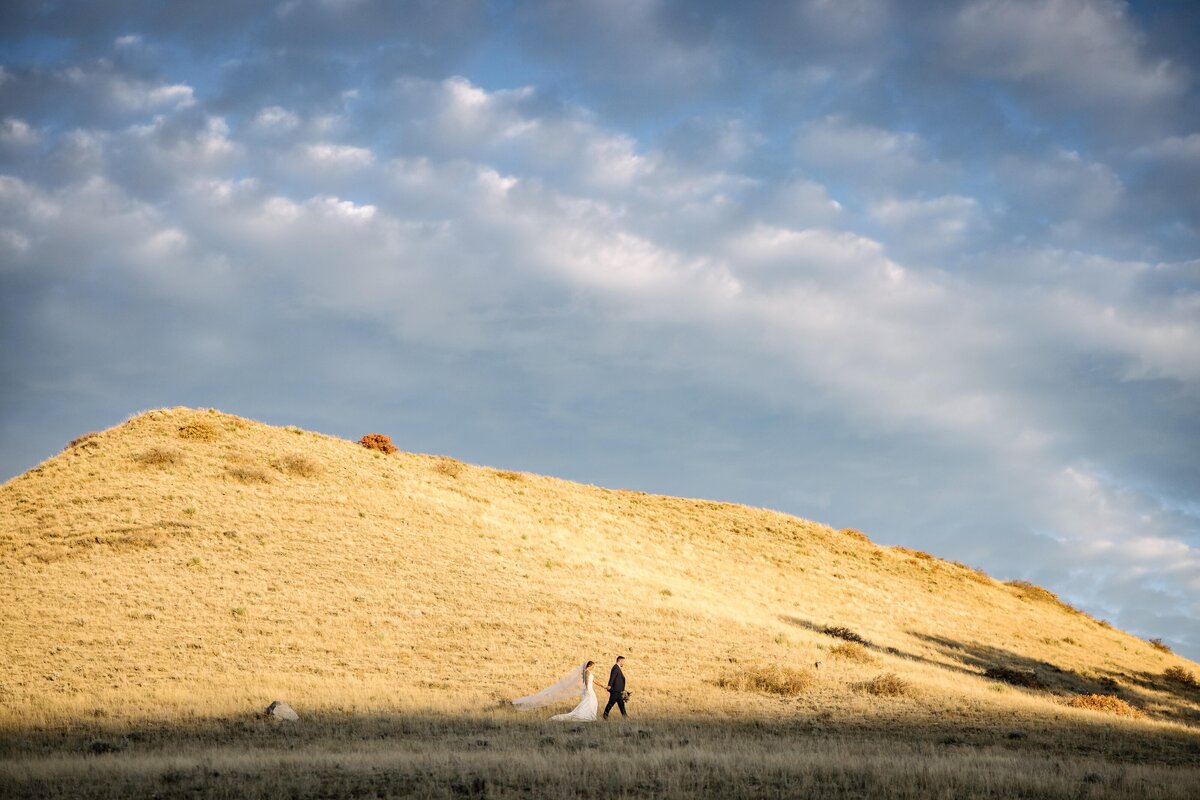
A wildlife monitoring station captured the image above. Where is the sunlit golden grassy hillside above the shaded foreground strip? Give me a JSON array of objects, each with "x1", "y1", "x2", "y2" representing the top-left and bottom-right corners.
[{"x1": 0, "y1": 409, "x2": 1200, "y2": 729}]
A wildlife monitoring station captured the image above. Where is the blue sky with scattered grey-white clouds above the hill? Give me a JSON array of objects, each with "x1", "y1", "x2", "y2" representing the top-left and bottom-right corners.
[{"x1": 0, "y1": 0, "x2": 1200, "y2": 658}]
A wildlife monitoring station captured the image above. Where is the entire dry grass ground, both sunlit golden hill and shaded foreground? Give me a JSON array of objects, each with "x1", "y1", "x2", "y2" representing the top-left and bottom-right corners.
[{"x1": 0, "y1": 408, "x2": 1200, "y2": 798}]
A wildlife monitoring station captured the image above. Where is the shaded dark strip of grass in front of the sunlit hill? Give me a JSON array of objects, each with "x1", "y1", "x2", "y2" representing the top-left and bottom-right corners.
[{"x1": 0, "y1": 711, "x2": 1200, "y2": 799}]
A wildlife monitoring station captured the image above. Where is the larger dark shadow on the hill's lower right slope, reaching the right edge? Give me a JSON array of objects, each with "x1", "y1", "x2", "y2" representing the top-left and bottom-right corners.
[{"x1": 907, "y1": 631, "x2": 1200, "y2": 726}]
